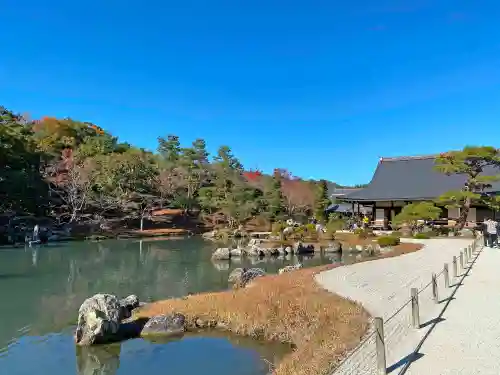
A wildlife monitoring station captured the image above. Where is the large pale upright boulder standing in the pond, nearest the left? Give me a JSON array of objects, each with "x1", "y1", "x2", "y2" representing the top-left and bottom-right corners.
[{"x1": 75, "y1": 294, "x2": 122, "y2": 345}]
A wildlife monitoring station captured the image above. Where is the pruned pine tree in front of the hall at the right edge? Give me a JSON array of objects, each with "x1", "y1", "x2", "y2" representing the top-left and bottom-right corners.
[{"x1": 435, "y1": 146, "x2": 500, "y2": 231}]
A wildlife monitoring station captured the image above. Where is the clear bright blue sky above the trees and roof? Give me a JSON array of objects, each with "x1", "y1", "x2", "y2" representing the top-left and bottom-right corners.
[{"x1": 0, "y1": 0, "x2": 500, "y2": 184}]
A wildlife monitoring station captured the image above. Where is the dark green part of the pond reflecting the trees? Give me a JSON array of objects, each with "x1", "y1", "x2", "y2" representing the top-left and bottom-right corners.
[{"x1": 0, "y1": 238, "x2": 336, "y2": 348}]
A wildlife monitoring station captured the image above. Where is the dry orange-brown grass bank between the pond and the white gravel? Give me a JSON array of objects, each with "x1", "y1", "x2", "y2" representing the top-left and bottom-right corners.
[{"x1": 137, "y1": 244, "x2": 421, "y2": 375}]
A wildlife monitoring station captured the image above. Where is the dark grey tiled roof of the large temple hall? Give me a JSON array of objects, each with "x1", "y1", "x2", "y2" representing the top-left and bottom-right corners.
[{"x1": 344, "y1": 155, "x2": 500, "y2": 201}]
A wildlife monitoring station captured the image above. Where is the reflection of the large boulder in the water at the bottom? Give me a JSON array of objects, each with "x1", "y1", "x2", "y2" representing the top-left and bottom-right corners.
[{"x1": 76, "y1": 344, "x2": 121, "y2": 375}]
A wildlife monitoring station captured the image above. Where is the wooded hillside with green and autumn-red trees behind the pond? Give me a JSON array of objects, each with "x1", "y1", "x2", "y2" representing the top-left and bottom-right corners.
[{"x1": 0, "y1": 107, "x2": 352, "y2": 231}]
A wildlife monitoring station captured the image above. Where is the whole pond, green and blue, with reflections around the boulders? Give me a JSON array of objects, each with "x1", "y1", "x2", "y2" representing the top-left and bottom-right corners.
[{"x1": 0, "y1": 237, "x2": 352, "y2": 375}]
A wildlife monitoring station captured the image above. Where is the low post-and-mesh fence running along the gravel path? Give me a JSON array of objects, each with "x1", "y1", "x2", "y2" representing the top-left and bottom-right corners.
[{"x1": 333, "y1": 237, "x2": 481, "y2": 375}]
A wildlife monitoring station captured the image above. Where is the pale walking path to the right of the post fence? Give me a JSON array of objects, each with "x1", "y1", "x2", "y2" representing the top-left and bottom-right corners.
[{"x1": 406, "y1": 244, "x2": 500, "y2": 375}]
